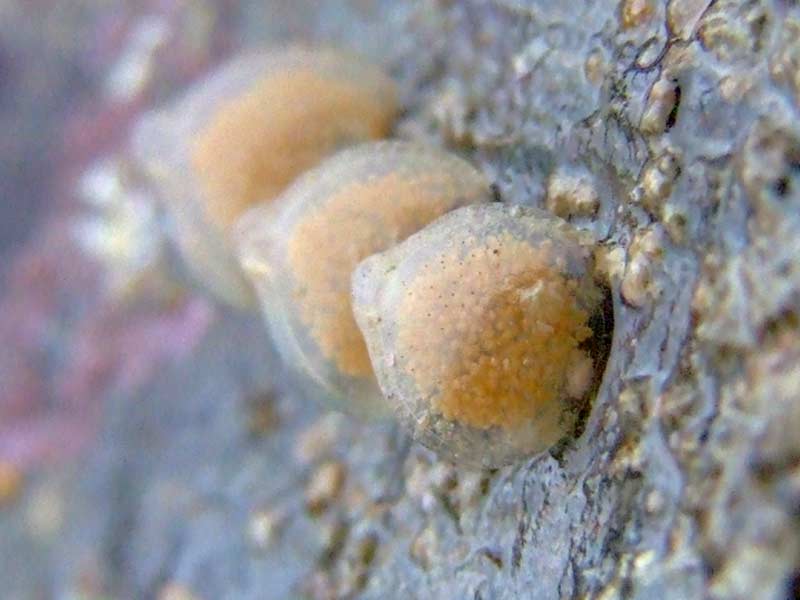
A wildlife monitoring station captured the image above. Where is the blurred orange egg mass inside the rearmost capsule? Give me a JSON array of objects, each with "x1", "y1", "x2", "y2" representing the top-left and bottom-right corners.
[{"x1": 191, "y1": 68, "x2": 396, "y2": 230}]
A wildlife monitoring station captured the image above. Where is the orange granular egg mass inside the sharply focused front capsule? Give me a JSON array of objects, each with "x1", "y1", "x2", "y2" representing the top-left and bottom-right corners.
[{"x1": 396, "y1": 234, "x2": 592, "y2": 429}]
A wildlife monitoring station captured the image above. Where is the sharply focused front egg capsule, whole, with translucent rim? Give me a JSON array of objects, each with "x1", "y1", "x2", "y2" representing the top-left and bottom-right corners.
[{"x1": 353, "y1": 203, "x2": 605, "y2": 467}]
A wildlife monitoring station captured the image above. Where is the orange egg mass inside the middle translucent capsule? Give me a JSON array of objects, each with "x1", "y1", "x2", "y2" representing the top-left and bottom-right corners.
[{"x1": 288, "y1": 172, "x2": 476, "y2": 377}]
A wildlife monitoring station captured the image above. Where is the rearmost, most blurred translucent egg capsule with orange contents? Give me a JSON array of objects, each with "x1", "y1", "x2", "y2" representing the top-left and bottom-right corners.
[{"x1": 134, "y1": 47, "x2": 406, "y2": 306}]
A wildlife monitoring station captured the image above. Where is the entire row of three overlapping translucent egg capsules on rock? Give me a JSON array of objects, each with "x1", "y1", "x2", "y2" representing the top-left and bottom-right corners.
[{"x1": 134, "y1": 47, "x2": 607, "y2": 467}]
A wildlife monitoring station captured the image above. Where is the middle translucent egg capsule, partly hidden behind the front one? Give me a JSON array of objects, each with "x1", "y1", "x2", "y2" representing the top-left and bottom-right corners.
[{"x1": 238, "y1": 141, "x2": 491, "y2": 417}]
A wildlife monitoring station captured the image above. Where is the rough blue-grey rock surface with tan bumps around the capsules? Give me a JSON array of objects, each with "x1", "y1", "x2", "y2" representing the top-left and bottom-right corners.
[{"x1": 0, "y1": 0, "x2": 800, "y2": 600}]
